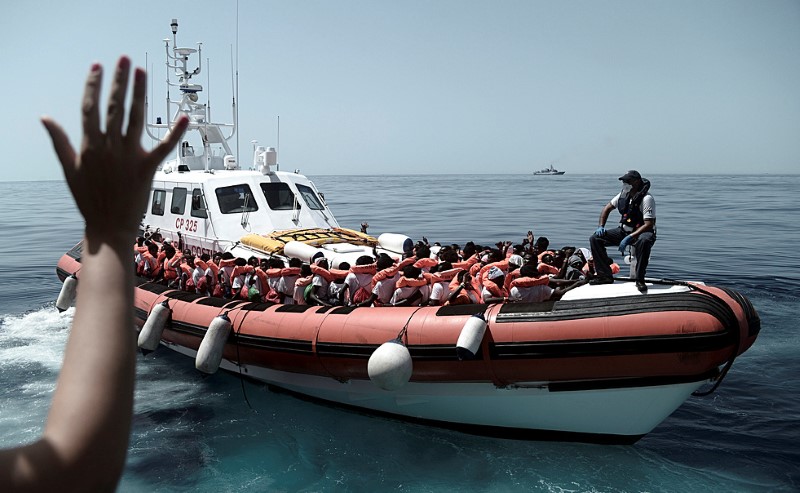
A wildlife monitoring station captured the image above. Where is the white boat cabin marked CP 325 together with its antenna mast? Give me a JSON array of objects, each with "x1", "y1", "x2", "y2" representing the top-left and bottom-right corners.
[{"x1": 141, "y1": 19, "x2": 339, "y2": 255}]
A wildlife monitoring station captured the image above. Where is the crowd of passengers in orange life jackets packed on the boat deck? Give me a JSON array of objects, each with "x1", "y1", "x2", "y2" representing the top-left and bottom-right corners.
[{"x1": 133, "y1": 231, "x2": 619, "y2": 306}]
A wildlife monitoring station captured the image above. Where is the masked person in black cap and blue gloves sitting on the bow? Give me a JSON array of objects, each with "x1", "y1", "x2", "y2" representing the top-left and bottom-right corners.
[{"x1": 589, "y1": 170, "x2": 656, "y2": 293}]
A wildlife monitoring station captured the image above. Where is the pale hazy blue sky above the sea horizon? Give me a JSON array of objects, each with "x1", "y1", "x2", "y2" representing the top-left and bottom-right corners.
[{"x1": 0, "y1": 0, "x2": 800, "y2": 180}]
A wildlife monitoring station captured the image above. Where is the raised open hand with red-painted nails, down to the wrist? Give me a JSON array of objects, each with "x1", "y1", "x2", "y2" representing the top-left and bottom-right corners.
[{"x1": 42, "y1": 56, "x2": 188, "y2": 243}]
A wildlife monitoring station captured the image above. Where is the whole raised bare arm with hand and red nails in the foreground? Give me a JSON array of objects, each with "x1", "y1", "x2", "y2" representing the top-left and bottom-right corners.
[{"x1": 0, "y1": 56, "x2": 188, "y2": 491}]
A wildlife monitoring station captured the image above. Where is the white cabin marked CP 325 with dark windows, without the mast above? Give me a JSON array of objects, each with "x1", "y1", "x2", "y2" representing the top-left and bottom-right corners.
[{"x1": 142, "y1": 161, "x2": 339, "y2": 254}]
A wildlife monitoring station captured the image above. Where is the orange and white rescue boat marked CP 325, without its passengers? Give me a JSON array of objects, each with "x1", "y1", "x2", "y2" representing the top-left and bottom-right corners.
[{"x1": 57, "y1": 20, "x2": 760, "y2": 443}]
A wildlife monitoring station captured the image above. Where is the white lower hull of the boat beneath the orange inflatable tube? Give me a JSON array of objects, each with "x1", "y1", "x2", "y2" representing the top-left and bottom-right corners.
[{"x1": 164, "y1": 343, "x2": 705, "y2": 442}]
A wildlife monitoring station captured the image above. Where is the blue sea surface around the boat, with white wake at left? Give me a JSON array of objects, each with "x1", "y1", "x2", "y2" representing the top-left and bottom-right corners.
[{"x1": 0, "y1": 175, "x2": 800, "y2": 493}]
